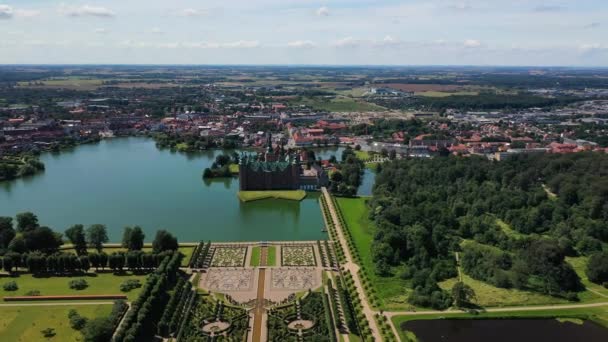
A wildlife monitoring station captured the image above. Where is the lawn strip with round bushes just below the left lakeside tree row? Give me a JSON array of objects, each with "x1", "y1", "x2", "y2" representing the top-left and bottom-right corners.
[{"x1": 0, "y1": 273, "x2": 146, "y2": 300}]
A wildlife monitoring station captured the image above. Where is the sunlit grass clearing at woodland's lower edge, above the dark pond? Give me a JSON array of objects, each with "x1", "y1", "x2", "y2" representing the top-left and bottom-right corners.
[{"x1": 439, "y1": 274, "x2": 570, "y2": 307}]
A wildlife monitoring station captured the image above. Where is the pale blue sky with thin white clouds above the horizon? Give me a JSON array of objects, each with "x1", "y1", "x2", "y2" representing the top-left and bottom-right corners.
[{"x1": 0, "y1": 0, "x2": 608, "y2": 66}]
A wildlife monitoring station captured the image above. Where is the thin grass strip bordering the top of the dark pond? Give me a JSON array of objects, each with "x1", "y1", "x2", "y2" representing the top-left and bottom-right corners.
[{"x1": 392, "y1": 306, "x2": 608, "y2": 341}]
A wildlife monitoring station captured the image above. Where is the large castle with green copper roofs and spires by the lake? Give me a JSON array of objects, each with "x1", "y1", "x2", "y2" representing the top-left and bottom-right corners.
[{"x1": 239, "y1": 135, "x2": 329, "y2": 191}]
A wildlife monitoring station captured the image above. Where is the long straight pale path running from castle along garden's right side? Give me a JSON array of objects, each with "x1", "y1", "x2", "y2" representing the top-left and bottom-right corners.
[{"x1": 321, "y1": 188, "x2": 382, "y2": 341}]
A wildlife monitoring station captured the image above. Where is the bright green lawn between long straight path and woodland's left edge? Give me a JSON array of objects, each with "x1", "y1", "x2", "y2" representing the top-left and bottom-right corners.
[{"x1": 337, "y1": 198, "x2": 412, "y2": 310}]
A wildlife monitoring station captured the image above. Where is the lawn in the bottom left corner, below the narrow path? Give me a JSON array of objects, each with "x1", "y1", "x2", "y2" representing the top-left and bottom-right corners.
[{"x1": 0, "y1": 304, "x2": 112, "y2": 342}]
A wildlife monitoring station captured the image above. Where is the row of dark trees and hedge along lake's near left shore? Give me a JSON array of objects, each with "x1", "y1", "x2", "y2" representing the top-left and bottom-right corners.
[{"x1": 0, "y1": 212, "x2": 178, "y2": 274}]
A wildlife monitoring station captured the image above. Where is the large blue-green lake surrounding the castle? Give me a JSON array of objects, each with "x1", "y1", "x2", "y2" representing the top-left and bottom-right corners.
[{"x1": 0, "y1": 138, "x2": 332, "y2": 242}]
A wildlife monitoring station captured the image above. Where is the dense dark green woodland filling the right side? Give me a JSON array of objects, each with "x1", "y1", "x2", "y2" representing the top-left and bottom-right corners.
[{"x1": 369, "y1": 153, "x2": 608, "y2": 308}]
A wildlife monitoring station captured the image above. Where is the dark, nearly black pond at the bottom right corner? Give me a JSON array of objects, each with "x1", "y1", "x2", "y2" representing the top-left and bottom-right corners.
[{"x1": 401, "y1": 319, "x2": 608, "y2": 342}]
